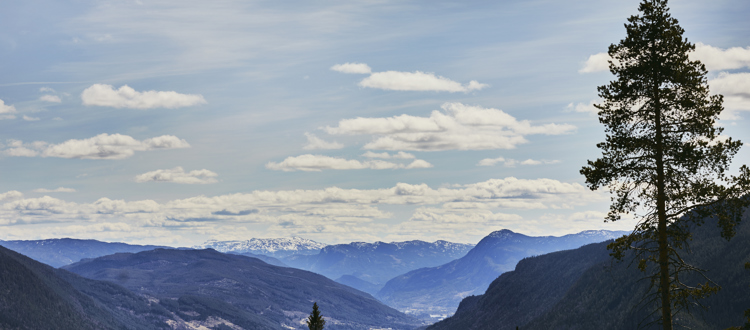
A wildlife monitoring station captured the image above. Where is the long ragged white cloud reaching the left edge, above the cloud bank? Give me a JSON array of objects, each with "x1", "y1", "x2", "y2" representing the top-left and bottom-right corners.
[{"x1": 4, "y1": 133, "x2": 190, "y2": 159}]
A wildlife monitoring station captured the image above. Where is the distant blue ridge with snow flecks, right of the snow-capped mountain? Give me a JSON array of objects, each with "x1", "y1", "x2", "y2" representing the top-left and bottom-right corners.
[{"x1": 282, "y1": 241, "x2": 473, "y2": 293}]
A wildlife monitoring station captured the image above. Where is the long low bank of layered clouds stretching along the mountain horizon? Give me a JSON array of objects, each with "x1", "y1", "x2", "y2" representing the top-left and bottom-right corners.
[{"x1": 0, "y1": 177, "x2": 607, "y2": 241}]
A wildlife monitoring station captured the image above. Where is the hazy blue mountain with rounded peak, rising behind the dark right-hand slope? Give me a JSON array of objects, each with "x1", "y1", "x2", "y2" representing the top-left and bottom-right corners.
[{"x1": 376, "y1": 229, "x2": 625, "y2": 316}]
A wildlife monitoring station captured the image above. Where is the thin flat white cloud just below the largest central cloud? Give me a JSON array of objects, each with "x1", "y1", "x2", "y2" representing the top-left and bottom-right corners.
[{"x1": 266, "y1": 154, "x2": 432, "y2": 172}]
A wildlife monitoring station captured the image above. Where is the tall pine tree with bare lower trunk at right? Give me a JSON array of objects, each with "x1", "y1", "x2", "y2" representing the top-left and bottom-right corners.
[{"x1": 581, "y1": 0, "x2": 750, "y2": 330}]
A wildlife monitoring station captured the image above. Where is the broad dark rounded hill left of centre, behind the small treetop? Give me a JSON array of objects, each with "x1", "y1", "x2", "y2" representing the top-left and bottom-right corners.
[{"x1": 65, "y1": 249, "x2": 420, "y2": 329}]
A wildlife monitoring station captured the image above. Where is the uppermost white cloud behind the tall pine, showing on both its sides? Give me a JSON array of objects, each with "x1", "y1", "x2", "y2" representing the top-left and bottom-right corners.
[{"x1": 578, "y1": 42, "x2": 750, "y2": 73}]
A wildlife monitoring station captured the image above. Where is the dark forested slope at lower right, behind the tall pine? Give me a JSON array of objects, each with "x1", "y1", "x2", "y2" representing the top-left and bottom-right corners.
[{"x1": 428, "y1": 212, "x2": 750, "y2": 330}]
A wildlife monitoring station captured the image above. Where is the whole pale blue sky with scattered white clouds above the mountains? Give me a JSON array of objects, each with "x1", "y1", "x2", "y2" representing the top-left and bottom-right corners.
[{"x1": 0, "y1": 0, "x2": 750, "y2": 246}]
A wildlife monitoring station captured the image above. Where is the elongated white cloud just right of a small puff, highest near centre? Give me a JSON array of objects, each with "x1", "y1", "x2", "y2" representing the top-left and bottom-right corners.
[{"x1": 359, "y1": 71, "x2": 489, "y2": 93}]
